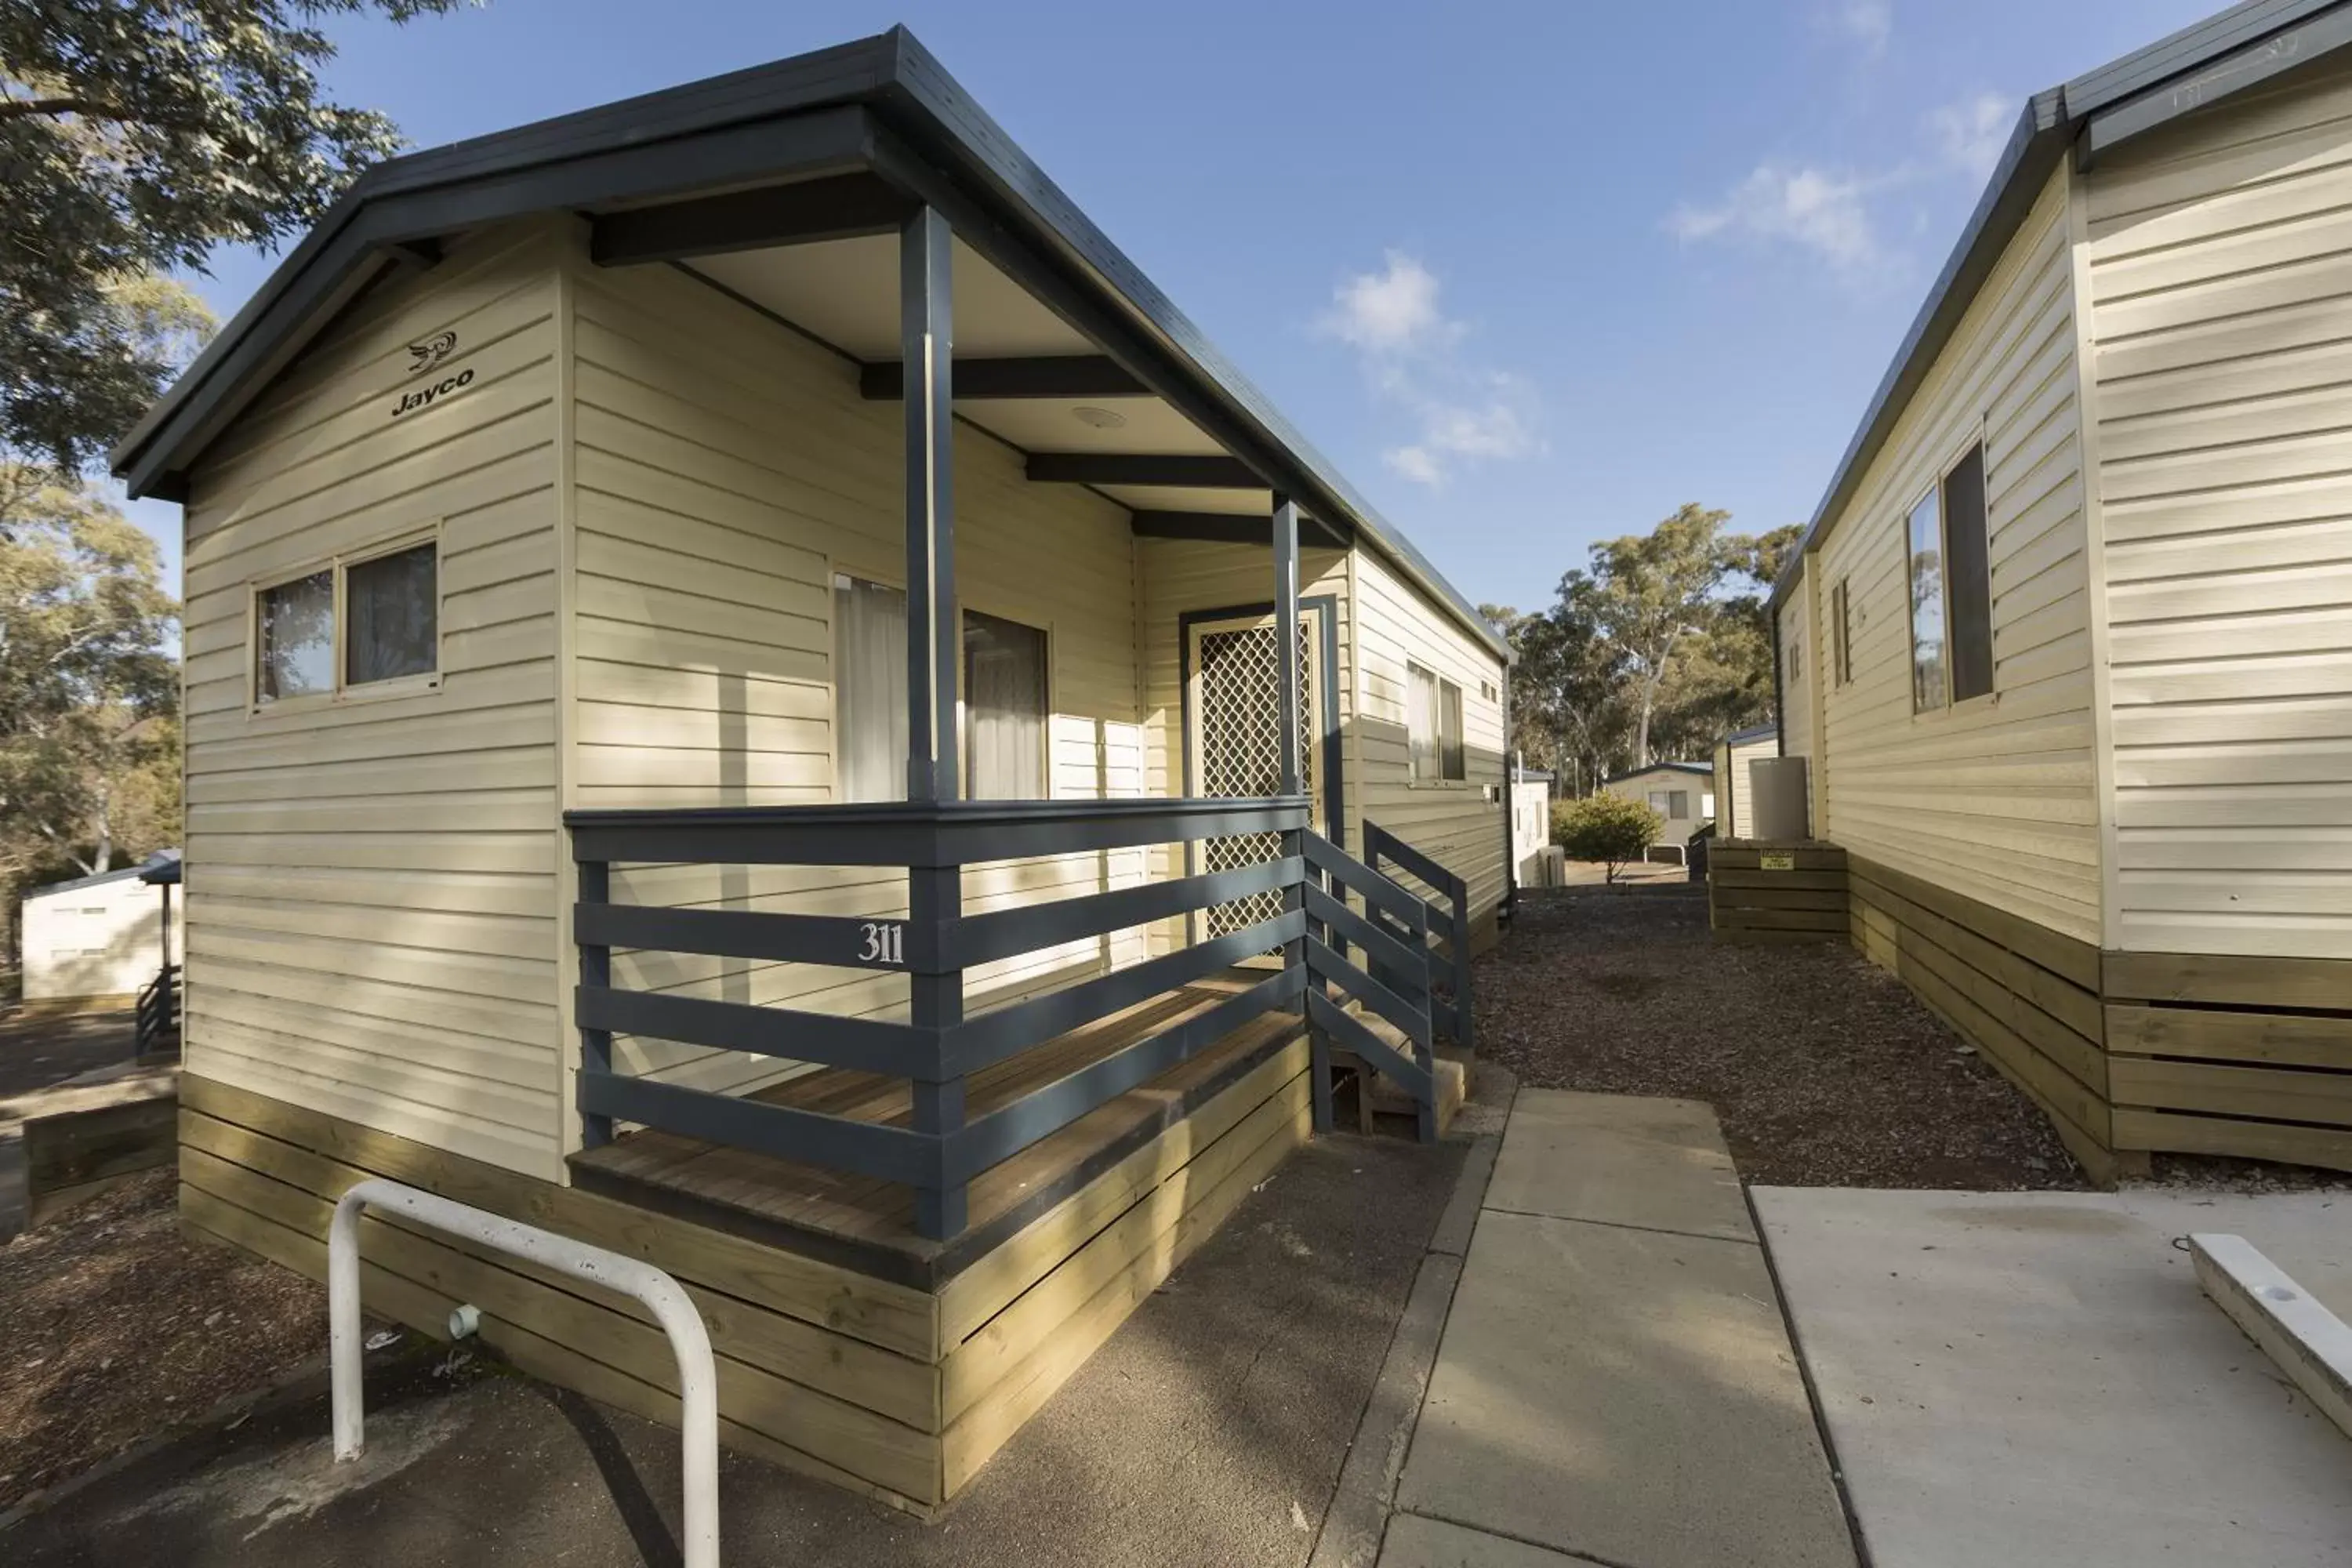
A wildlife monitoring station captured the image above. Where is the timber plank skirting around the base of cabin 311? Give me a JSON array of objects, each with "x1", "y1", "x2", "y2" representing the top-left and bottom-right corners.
[{"x1": 179, "y1": 1039, "x2": 1310, "y2": 1516}]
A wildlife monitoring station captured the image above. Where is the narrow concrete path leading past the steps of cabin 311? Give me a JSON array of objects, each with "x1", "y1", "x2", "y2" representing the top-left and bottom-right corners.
[{"x1": 1378, "y1": 1088, "x2": 1856, "y2": 1568}]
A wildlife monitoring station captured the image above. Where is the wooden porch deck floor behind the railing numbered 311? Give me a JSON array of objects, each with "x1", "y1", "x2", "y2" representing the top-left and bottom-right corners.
[{"x1": 572, "y1": 971, "x2": 1301, "y2": 1290}]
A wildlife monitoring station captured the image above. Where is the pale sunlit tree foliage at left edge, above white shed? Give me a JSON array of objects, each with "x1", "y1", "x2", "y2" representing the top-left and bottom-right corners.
[{"x1": 0, "y1": 463, "x2": 179, "y2": 881}]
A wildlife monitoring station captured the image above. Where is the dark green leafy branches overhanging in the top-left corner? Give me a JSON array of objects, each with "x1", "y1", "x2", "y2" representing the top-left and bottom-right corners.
[{"x1": 0, "y1": 0, "x2": 473, "y2": 473}]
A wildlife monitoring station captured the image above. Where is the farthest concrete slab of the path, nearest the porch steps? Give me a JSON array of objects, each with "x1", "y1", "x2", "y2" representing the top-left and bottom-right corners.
[{"x1": 1486, "y1": 1088, "x2": 1755, "y2": 1241}]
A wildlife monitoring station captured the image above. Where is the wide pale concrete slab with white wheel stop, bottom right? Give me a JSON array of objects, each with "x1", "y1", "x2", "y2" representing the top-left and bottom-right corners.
[{"x1": 1755, "y1": 1187, "x2": 2352, "y2": 1568}]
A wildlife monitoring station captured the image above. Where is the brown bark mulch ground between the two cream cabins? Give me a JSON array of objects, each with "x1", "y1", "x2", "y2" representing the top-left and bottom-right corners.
[{"x1": 1472, "y1": 884, "x2": 2089, "y2": 1192}]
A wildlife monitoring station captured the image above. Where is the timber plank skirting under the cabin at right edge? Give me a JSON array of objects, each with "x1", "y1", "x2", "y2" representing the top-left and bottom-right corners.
[{"x1": 1849, "y1": 855, "x2": 2352, "y2": 1182}]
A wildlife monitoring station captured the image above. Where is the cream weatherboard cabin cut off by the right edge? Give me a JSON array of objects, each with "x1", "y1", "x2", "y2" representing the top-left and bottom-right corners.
[{"x1": 1773, "y1": 2, "x2": 2352, "y2": 1173}]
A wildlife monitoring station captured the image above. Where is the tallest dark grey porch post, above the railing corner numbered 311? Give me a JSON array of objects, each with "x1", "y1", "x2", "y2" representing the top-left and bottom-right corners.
[{"x1": 898, "y1": 207, "x2": 962, "y2": 799}]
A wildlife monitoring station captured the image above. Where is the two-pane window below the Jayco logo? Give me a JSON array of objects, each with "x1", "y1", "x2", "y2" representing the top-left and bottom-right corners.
[{"x1": 254, "y1": 539, "x2": 440, "y2": 708}]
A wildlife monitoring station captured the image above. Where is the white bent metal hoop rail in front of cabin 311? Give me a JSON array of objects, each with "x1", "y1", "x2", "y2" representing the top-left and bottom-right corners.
[{"x1": 327, "y1": 1178, "x2": 720, "y2": 1568}]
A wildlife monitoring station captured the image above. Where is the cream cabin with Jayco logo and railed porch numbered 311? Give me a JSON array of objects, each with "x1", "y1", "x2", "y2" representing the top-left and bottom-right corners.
[{"x1": 115, "y1": 31, "x2": 1510, "y2": 1514}]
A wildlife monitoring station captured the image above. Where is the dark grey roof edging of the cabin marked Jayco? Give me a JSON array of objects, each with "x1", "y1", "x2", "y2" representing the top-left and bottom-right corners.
[{"x1": 113, "y1": 26, "x2": 1510, "y2": 661}]
